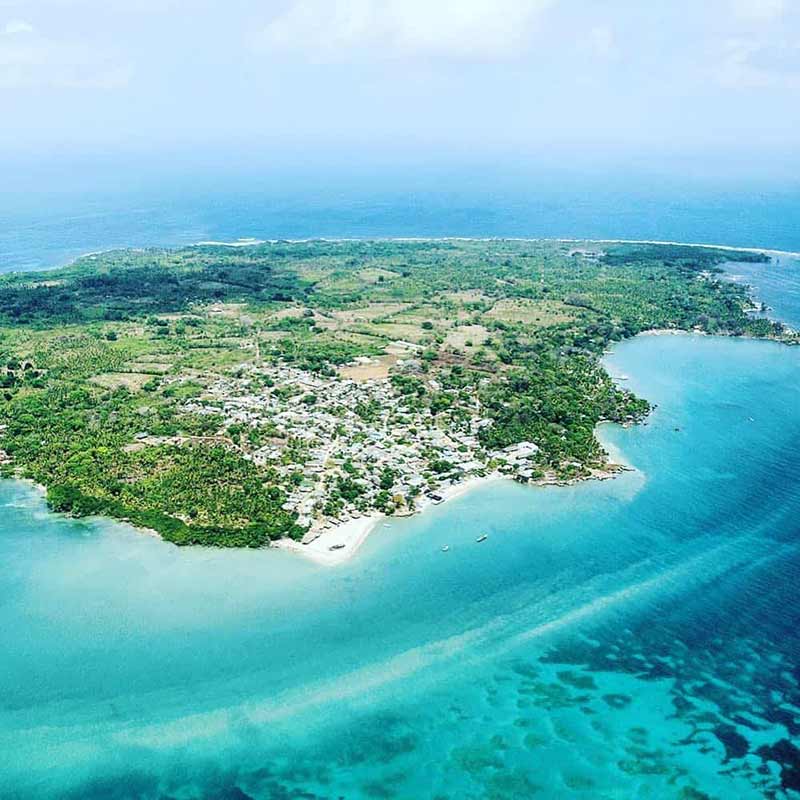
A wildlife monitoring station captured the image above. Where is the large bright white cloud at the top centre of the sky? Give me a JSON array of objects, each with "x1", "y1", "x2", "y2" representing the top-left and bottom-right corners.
[{"x1": 255, "y1": 0, "x2": 555, "y2": 61}]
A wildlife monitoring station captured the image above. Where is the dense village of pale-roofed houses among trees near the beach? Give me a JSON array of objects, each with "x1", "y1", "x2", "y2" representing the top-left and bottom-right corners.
[{"x1": 183, "y1": 357, "x2": 539, "y2": 542}]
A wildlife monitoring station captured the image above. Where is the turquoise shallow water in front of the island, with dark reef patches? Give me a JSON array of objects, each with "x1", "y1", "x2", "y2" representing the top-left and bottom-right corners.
[{"x1": 0, "y1": 265, "x2": 800, "y2": 800}]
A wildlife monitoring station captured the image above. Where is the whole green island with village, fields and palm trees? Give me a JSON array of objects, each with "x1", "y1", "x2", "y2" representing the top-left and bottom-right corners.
[{"x1": 0, "y1": 240, "x2": 797, "y2": 560}]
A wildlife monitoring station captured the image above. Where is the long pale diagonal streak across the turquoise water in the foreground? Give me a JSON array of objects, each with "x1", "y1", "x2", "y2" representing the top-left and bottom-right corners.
[{"x1": 73, "y1": 536, "x2": 795, "y2": 746}]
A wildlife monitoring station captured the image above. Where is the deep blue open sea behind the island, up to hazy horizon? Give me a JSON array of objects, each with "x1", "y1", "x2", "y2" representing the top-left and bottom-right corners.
[{"x1": 0, "y1": 165, "x2": 800, "y2": 272}]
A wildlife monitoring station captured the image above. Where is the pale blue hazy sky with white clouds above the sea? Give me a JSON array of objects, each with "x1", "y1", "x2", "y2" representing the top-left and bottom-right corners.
[{"x1": 0, "y1": 0, "x2": 800, "y2": 171}]
